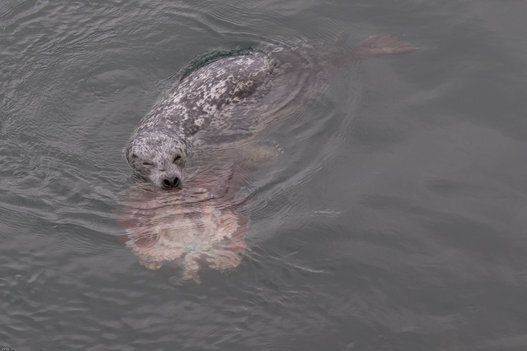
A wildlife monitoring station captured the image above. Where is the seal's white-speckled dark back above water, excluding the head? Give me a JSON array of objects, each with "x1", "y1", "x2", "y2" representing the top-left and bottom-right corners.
[{"x1": 144, "y1": 53, "x2": 273, "y2": 139}]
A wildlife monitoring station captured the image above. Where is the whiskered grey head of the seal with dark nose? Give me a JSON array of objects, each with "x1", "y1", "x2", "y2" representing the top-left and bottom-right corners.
[{"x1": 125, "y1": 132, "x2": 187, "y2": 189}]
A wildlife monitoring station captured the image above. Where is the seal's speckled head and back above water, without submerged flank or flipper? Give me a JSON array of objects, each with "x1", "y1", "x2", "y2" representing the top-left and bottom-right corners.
[{"x1": 126, "y1": 52, "x2": 277, "y2": 188}]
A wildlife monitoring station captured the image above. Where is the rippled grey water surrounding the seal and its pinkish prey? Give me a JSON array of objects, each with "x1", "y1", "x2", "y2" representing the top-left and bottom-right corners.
[{"x1": 0, "y1": 0, "x2": 527, "y2": 351}]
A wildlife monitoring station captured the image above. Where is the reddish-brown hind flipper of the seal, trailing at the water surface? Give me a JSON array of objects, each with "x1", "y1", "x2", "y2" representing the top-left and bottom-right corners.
[{"x1": 351, "y1": 35, "x2": 417, "y2": 57}]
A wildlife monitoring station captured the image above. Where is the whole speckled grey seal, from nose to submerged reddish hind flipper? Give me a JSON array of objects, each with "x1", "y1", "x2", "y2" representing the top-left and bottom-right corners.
[{"x1": 125, "y1": 36, "x2": 415, "y2": 189}]
